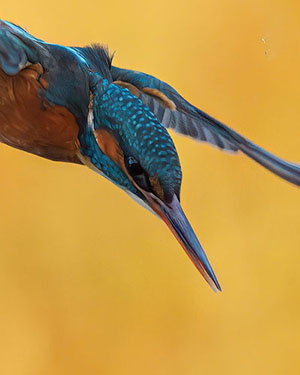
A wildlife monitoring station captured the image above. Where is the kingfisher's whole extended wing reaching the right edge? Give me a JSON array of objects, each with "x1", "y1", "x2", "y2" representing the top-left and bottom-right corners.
[{"x1": 111, "y1": 66, "x2": 300, "y2": 186}]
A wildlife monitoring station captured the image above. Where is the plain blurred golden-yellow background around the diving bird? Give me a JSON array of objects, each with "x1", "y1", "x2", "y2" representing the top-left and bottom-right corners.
[{"x1": 0, "y1": 0, "x2": 300, "y2": 375}]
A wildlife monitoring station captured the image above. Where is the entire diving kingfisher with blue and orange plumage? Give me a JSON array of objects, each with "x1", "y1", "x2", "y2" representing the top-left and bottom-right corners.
[{"x1": 0, "y1": 20, "x2": 300, "y2": 290}]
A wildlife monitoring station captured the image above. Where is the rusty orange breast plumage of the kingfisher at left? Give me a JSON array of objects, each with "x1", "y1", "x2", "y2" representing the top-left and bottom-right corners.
[{"x1": 0, "y1": 64, "x2": 80, "y2": 163}]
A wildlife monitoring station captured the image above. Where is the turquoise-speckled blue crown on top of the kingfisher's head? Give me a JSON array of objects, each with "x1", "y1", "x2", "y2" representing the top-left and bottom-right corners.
[{"x1": 92, "y1": 75, "x2": 182, "y2": 196}]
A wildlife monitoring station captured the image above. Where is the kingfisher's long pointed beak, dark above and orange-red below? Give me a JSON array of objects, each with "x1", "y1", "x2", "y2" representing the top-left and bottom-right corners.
[{"x1": 149, "y1": 195, "x2": 221, "y2": 292}]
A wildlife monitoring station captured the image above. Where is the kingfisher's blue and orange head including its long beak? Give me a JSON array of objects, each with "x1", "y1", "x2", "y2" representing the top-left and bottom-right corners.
[{"x1": 81, "y1": 78, "x2": 221, "y2": 290}]
